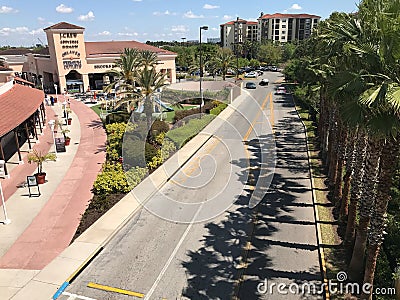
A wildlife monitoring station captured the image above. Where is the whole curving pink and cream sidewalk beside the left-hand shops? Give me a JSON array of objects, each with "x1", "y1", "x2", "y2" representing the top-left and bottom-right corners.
[{"x1": 0, "y1": 97, "x2": 106, "y2": 299}]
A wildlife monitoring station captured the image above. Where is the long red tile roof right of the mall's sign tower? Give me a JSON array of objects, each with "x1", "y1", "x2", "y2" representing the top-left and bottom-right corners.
[{"x1": 85, "y1": 41, "x2": 176, "y2": 57}]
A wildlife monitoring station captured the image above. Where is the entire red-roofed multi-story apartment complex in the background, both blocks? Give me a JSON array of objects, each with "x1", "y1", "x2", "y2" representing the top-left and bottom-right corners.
[{"x1": 220, "y1": 13, "x2": 321, "y2": 50}]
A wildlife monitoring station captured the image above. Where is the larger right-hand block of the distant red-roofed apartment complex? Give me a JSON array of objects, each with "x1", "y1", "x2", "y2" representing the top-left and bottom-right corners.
[{"x1": 257, "y1": 13, "x2": 321, "y2": 43}]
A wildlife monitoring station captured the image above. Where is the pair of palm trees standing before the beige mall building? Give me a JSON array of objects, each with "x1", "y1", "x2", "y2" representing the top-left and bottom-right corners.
[{"x1": 104, "y1": 48, "x2": 166, "y2": 129}]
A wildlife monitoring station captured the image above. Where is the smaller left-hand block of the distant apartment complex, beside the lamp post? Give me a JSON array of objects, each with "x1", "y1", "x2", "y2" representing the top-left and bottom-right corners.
[{"x1": 220, "y1": 18, "x2": 258, "y2": 50}]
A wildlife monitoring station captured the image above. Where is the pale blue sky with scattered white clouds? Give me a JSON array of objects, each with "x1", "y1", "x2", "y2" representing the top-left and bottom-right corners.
[{"x1": 0, "y1": 0, "x2": 359, "y2": 47}]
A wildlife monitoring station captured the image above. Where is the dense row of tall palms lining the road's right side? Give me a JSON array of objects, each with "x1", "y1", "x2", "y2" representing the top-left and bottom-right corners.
[{"x1": 290, "y1": 0, "x2": 400, "y2": 299}]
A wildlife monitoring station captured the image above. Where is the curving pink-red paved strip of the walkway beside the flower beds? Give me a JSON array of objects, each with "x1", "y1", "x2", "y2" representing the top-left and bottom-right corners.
[{"x1": 0, "y1": 99, "x2": 106, "y2": 270}]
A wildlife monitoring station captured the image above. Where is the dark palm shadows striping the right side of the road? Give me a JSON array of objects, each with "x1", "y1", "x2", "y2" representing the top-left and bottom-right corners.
[{"x1": 182, "y1": 115, "x2": 322, "y2": 300}]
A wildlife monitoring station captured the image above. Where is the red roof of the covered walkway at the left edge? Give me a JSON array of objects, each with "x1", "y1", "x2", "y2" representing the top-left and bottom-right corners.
[{"x1": 0, "y1": 84, "x2": 44, "y2": 137}]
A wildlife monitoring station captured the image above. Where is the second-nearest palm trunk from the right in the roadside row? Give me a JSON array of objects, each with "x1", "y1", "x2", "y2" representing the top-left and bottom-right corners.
[{"x1": 349, "y1": 138, "x2": 382, "y2": 281}]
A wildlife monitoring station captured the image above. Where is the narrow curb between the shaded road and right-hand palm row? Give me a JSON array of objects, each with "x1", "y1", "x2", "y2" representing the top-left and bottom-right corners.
[{"x1": 291, "y1": 95, "x2": 330, "y2": 300}]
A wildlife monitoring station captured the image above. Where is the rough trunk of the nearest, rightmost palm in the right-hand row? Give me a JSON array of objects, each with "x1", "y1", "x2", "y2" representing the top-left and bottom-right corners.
[{"x1": 361, "y1": 139, "x2": 399, "y2": 299}]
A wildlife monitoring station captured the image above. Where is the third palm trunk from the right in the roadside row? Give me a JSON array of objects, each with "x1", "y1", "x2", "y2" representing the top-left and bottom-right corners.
[{"x1": 345, "y1": 129, "x2": 367, "y2": 245}]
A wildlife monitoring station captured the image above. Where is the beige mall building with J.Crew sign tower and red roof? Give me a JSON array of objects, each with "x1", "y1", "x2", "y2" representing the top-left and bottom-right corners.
[{"x1": 0, "y1": 22, "x2": 176, "y2": 93}]
